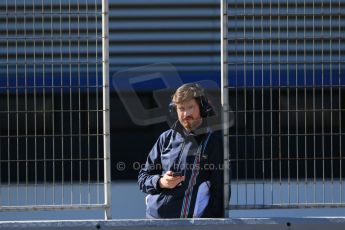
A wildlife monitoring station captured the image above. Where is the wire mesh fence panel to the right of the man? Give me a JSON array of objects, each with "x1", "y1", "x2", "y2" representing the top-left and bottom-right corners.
[{"x1": 222, "y1": 0, "x2": 345, "y2": 209}]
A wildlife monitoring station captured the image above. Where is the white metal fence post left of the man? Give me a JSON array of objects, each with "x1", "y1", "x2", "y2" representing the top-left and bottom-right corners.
[{"x1": 102, "y1": 0, "x2": 111, "y2": 220}]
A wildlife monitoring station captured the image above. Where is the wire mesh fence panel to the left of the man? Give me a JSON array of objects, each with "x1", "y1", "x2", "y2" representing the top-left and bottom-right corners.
[{"x1": 0, "y1": 0, "x2": 110, "y2": 217}]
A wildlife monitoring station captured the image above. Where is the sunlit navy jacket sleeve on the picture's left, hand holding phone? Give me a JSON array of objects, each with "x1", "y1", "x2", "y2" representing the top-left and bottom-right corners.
[{"x1": 138, "y1": 135, "x2": 163, "y2": 194}]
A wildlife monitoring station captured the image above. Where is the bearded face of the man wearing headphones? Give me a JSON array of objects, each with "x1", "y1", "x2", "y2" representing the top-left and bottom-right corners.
[{"x1": 176, "y1": 99, "x2": 202, "y2": 131}]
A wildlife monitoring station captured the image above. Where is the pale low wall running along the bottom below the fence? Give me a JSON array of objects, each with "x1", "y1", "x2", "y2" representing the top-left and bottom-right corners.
[{"x1": 0, "y1": 218, "x2": 345, "y2": 230}]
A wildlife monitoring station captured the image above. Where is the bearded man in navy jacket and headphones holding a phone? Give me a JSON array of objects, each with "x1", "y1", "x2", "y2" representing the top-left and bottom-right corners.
[{"x1": 138, "y1": 83, "x2": 224, "y2": 218}]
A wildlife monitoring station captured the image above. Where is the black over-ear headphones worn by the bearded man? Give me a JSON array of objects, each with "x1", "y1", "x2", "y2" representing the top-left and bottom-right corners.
[{"x1": 169, "y1": 83, "x2": 215, "y2": 119}]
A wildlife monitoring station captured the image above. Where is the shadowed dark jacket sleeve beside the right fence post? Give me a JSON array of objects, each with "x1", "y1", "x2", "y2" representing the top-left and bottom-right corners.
[{"x1": 202, "y1": 133, "x2": 224, "y2": 218}]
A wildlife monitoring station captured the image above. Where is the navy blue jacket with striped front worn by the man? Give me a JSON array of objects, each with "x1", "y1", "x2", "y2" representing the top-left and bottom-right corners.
[{"x1": 138, "y1": 122, "x2": 223, "y2": 218}]
